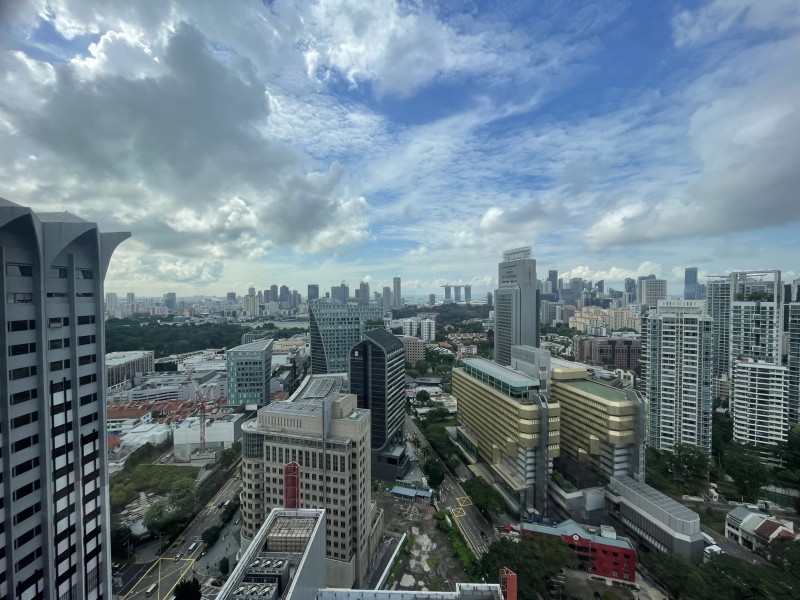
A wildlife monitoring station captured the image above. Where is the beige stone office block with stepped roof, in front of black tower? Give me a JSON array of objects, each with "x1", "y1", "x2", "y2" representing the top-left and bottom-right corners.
[{"x1": 241, "y1": 376, "x2": 380, "y2": 587}]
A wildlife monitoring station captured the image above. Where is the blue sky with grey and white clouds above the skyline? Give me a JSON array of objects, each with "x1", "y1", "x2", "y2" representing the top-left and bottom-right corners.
[{"x1": 0, "y1": 0, "x2": 800, "y2": 297}]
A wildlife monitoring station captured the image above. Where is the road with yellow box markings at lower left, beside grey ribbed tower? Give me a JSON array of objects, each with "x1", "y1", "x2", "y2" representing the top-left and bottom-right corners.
[{"x1": 121, "y1": 469, "x2": 241, "y2": 600}]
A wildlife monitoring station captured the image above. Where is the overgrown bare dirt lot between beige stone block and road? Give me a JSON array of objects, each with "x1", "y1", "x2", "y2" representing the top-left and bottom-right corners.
[{"x1": 373, "y1": 493, "x2": 467, "y2": 591}]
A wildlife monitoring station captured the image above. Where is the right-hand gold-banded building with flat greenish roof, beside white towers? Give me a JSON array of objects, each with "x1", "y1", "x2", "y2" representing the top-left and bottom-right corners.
[{"x1": 550, "y1": 368, "x2": 646, "y2": 479}]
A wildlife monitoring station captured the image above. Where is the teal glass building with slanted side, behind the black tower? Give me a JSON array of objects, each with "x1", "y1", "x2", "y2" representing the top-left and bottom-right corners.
[{"x1": 309, "y1": 300, "x2": 383, "y2": 375}]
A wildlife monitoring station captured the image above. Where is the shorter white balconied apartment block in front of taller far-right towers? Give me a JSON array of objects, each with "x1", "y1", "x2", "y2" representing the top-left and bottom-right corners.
[{"x1": 730, "y1": 358, "x2": 789, "y2": 466}]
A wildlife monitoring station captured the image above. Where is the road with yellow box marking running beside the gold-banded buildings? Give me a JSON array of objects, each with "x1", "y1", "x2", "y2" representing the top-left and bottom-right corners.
[{"x1": 406, "y1": 416, "x2": 497, "y2": 557}]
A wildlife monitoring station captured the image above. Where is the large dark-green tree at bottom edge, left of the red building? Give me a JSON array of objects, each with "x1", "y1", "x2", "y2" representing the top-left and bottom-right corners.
[{"x1": 478, "y1": 534, "x2": 578, "y2": 599}]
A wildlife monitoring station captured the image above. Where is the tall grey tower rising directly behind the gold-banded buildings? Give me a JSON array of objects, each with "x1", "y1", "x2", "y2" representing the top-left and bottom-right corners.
[{"x1": 494, "y1": 246, "x2": 539, "y2": 365}]
